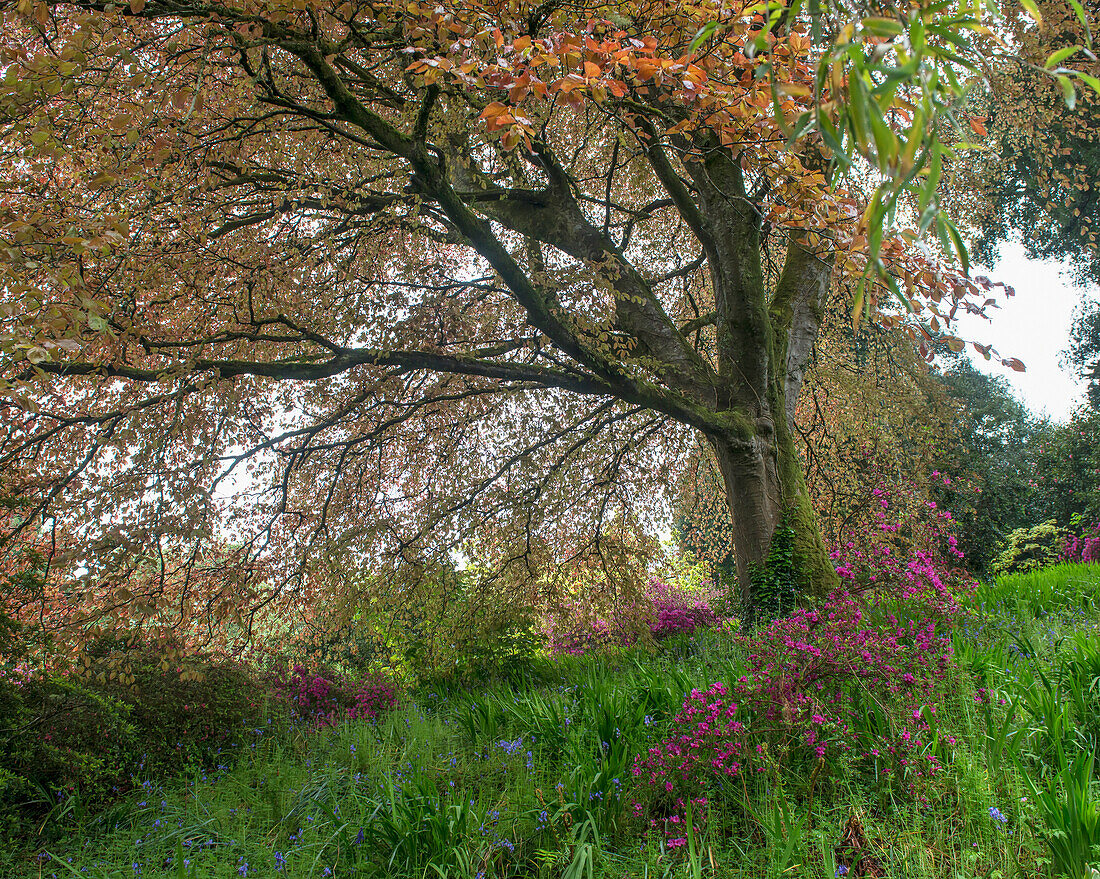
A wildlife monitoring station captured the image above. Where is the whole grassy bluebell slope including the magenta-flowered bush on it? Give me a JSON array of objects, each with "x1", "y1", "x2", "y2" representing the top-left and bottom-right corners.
[{"x1": 8, "y1": 554, "x2": 1100, "y2": 879}]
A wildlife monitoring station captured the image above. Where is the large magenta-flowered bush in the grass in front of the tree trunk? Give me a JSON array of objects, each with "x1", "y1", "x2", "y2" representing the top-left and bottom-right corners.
[{"x1": 634, "y1": 481, "x2": 970, "y2": 844}]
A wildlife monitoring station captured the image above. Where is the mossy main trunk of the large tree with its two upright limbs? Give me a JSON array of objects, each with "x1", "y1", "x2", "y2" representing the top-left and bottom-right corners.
[{"x1": 695, "y1": 190, "x2": 837, "y2": 627}]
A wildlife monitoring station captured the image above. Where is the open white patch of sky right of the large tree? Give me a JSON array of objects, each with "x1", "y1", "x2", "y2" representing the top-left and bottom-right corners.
[{"x1": 958, "y1": 242, "x2": 1100, "y2": 421}]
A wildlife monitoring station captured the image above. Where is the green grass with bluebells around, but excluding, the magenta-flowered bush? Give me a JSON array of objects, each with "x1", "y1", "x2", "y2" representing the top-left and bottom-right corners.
[{"x1": 17, "y1": 565, "x2": 1100, "y2": 879}]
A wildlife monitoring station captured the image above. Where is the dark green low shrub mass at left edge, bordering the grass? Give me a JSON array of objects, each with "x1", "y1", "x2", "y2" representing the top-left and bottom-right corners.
[{"x1": 0, "y1": 641, "x2": 265, "y2": 839}]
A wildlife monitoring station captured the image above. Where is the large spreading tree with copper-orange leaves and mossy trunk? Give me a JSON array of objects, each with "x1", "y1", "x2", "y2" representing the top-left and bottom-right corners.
[{"x1": 0, "y1": 0, "x2": 1029, "y2": 624}]
